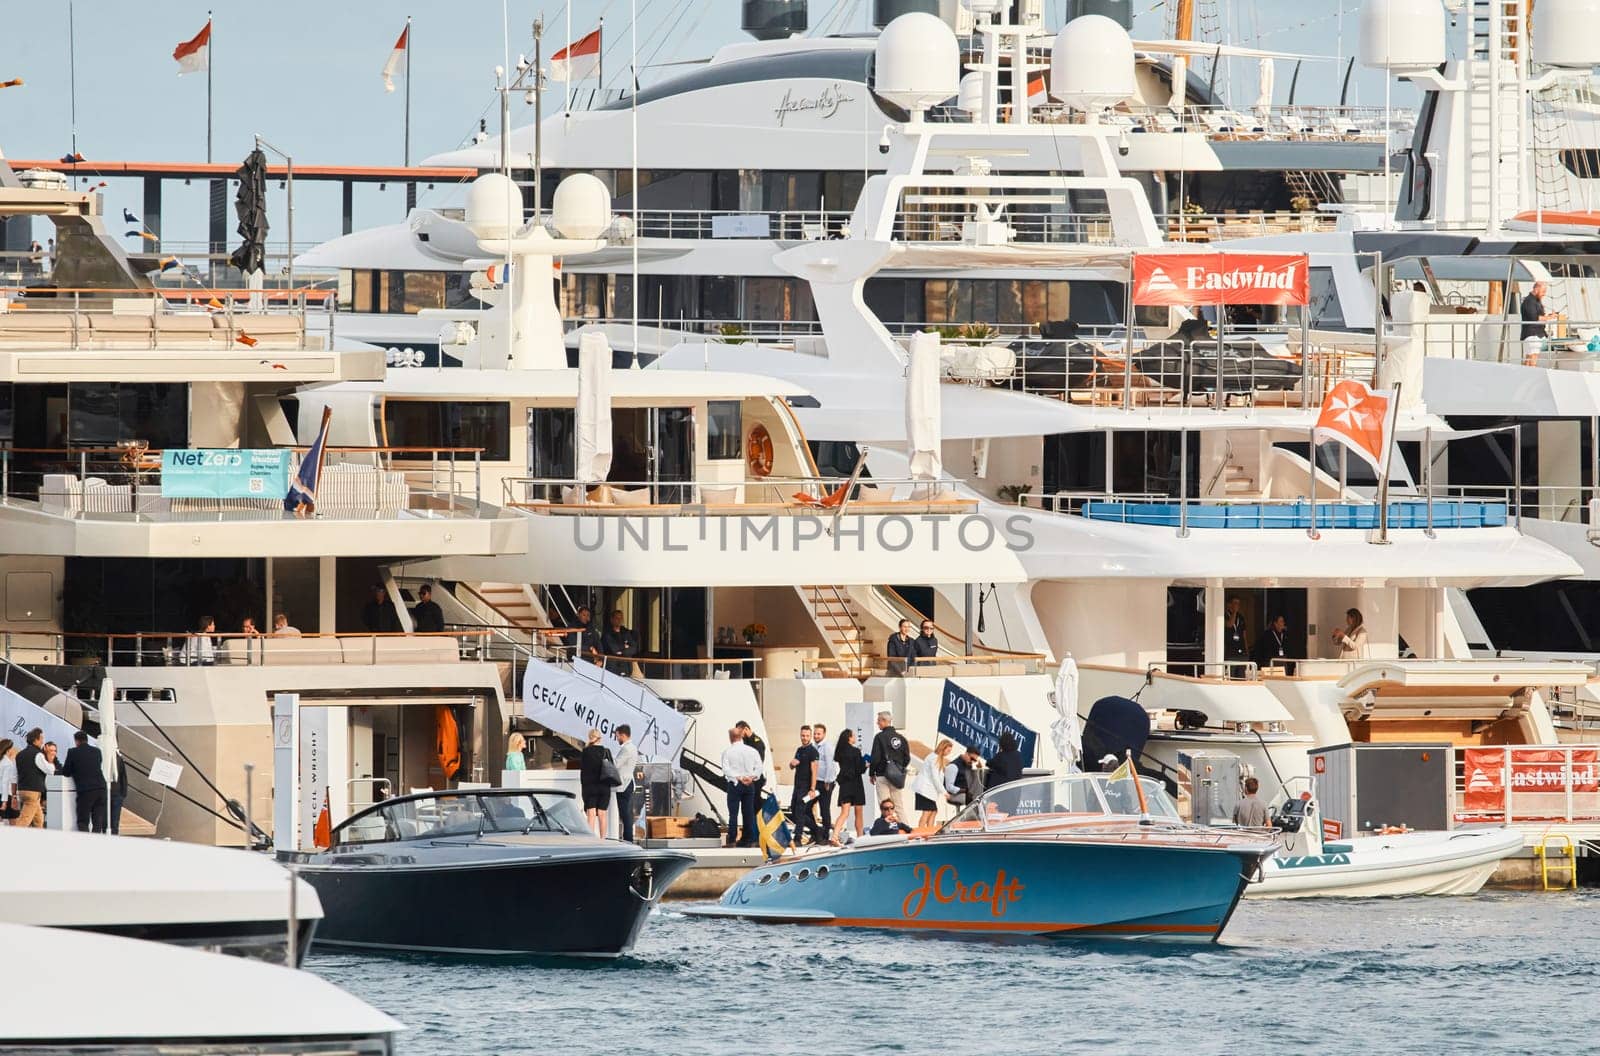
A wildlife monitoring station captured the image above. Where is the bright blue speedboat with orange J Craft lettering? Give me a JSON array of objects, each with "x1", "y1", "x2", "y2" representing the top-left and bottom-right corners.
[{"x1": 685, "y1": 774, "x2": 1277, "y2": 941}]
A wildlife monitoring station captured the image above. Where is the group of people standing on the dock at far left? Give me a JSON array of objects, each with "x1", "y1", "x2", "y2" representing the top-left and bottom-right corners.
[{"x1": 0, "y1": 726, "x2": 128, "y2": 835}]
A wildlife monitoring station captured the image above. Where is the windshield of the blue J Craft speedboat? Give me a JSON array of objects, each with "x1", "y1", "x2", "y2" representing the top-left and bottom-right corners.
[{"x1": 950, "y1": 774, "x2": 1179, "y2": 832}]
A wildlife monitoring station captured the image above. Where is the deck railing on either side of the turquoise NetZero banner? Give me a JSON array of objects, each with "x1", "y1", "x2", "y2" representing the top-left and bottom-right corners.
[{"x1": 0, "y1": 442, "x2": 494, "y2": 523}]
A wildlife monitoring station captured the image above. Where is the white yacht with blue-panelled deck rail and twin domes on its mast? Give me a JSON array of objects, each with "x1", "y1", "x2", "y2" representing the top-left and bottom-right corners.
[{"x1": 643, "y1": 4, "x2": 1594, "y2": 825}]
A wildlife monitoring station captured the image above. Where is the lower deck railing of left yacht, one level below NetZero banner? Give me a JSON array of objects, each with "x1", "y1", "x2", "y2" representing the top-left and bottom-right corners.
[{"x1": 0, "y1": 629, "x2": 490, "y2": 667}]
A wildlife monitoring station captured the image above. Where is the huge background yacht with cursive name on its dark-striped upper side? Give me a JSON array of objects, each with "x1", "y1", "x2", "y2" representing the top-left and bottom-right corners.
[{"x1": 296, "y1": 0, "x2": 1413, "y2": 363}]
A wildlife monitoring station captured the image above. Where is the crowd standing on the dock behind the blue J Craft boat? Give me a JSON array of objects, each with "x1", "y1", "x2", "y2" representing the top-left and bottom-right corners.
[{"x1": 720, "y1": 712, "x2": 1026, "y2": 848}]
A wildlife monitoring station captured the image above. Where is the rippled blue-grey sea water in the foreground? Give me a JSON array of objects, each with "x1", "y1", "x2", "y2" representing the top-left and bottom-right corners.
[{"x1": 307, "y1": 891, "x2": 1600, "y2": 1056}]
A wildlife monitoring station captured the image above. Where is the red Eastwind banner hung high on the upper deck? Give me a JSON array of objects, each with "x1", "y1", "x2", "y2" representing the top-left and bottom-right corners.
[{"x1": 1133, "y1": 253, "x2": 1310, "y2": 306}]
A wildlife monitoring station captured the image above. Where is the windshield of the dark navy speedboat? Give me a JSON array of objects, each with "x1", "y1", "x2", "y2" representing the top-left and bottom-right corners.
[{"x1": 333, "y1": 792, "x2": 589, "y2": 846}]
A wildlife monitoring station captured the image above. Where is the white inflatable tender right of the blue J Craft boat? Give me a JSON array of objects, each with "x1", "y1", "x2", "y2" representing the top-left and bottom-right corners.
[{"x1": 1245, "y1": 829, "x2": 1522, "y2": 898}]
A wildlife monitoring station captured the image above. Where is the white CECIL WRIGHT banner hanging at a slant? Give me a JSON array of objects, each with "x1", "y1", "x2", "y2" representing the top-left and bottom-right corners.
[{"x1": 522, "y1": 661, "x2": 685, "y2": 763}]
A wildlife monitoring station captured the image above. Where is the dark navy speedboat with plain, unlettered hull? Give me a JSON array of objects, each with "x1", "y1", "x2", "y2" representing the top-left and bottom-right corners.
[{"x1": 286, "y1": 789, "x2": 694, "y2": 957}]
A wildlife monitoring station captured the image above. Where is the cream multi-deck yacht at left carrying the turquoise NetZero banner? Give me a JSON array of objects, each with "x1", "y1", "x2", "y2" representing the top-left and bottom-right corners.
[{"x1": 0, "y1": 162, "x2": 520, "y2": 845}]
